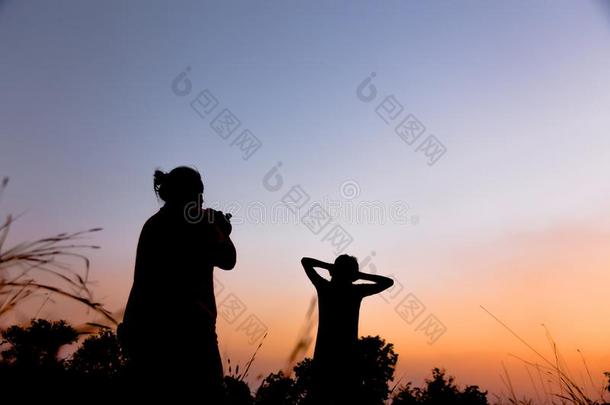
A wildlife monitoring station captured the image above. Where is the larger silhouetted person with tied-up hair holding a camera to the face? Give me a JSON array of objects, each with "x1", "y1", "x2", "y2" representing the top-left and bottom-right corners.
[{"x1": 119, "y1": 167, "x2": 236, "y2": 403}]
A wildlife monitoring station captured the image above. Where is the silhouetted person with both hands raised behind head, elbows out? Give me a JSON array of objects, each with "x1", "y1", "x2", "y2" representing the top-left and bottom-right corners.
[{"x1": 301, "y1": 255, "x2": 394, "y2": 404}]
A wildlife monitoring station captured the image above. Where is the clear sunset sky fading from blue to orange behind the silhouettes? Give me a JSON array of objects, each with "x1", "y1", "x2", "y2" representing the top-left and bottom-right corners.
[{"x1": 0, "y1": 0, "x2": 610, "y2": 393}]
